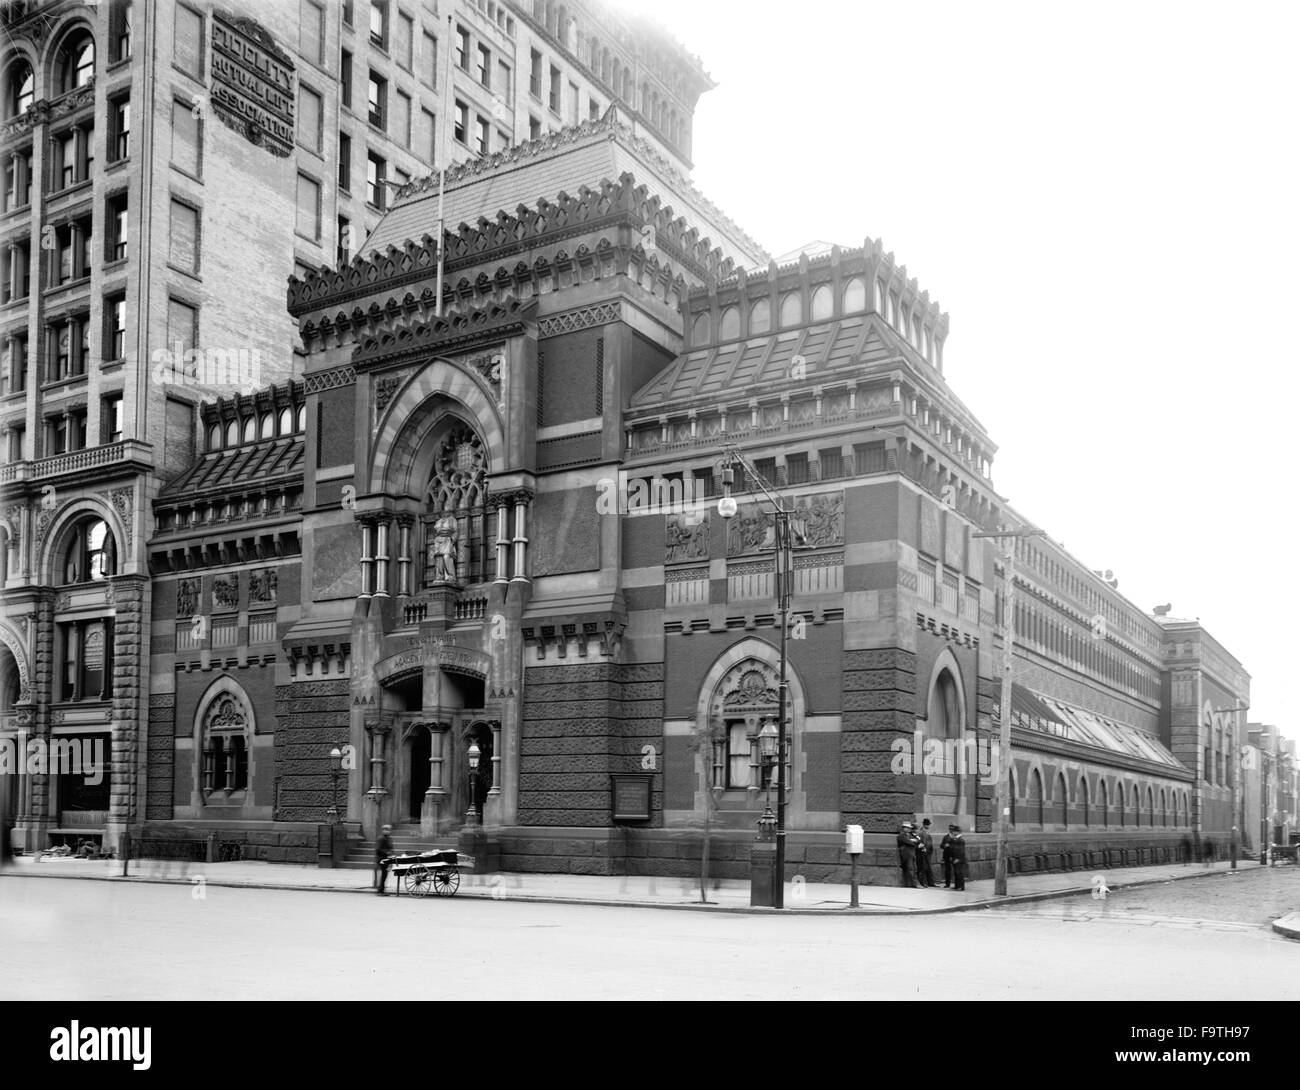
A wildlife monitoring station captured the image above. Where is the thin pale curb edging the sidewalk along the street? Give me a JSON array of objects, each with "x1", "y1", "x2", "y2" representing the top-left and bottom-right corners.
[{"x1": 0, "y1": 868, "x2": 1258, "y2": 915}]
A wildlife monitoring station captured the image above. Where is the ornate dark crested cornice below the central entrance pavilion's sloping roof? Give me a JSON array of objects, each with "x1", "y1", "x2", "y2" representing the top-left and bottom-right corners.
[{"x1": 289, "y1": 173, "x2": 735, "y2": 317}]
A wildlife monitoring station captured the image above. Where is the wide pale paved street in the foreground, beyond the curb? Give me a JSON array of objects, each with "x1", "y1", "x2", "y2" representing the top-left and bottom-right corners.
[{"x1": 0, "y1": 869, "x2": 1300, "y2": 1000}]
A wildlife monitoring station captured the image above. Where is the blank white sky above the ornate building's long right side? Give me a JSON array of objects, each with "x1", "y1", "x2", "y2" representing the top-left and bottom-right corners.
[{"x1": 624, "y1": 0, "x2": 1300, "y2": 738}]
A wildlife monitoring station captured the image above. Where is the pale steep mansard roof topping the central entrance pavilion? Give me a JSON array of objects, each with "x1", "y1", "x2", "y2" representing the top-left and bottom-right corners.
[{"x1": 365, "y1": 107, "x2": 768, "y2": 265}]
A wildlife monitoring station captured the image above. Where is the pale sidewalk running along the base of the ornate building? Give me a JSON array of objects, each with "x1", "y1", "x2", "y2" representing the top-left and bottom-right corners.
[{"x1": 0, "y1": 856, "x2": 1263, "y2": 926}]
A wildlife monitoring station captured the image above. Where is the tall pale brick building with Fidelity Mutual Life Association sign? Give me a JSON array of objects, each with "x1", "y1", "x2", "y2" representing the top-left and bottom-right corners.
[{"x1": 0, "y1": 0, "x2": 711, "y2": 847}]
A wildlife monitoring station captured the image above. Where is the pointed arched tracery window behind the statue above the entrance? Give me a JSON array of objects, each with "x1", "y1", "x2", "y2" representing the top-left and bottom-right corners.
[{"x1": 423, "y1": 421, "x2": 497, "y2": 587}]
